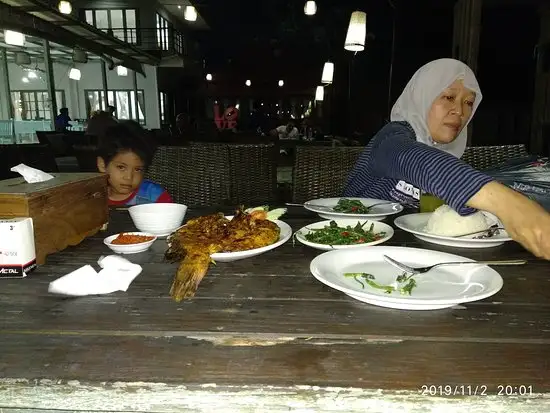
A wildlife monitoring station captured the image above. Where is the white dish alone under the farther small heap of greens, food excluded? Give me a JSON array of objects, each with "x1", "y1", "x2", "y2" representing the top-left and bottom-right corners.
[{"x1": 304, "y1": 197, "x2": 403, "y2": 221}]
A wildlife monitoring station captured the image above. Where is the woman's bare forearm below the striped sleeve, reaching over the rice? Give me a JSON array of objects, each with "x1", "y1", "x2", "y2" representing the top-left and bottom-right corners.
[{"x1": 468, "y1": 182, "x2": 550, "y2": 260}]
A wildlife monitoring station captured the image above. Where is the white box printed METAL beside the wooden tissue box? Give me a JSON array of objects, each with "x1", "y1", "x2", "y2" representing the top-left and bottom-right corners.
[{"x1": 0, "y1": 218, "x2": 36, "y2": 279}]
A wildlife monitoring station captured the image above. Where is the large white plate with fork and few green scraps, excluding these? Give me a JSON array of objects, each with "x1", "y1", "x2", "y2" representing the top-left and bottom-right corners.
[{"x1": 310, "y1": 246, "x2": 502, "y2": 310}]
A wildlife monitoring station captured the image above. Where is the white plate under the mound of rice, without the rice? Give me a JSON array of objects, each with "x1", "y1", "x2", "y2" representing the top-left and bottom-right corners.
[{"x1": 394, "y1": 212, "x2": 512, "y2": 248}]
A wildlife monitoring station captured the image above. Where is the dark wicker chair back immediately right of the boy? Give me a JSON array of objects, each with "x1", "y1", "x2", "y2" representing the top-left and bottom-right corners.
[{"x1": 146, "y1": 145, "x2": 230, "y2": 207}]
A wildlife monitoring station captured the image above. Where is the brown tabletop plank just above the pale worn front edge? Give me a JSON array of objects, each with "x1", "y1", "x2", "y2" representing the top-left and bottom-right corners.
[{"x1": 0, "y1": 334, "x2": 550, "y2": 390}]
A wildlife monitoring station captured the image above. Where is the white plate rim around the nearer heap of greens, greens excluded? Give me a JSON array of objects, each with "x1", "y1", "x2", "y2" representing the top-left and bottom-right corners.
[{"x1": 295, "y1": 218, "x2": 394, "y2": 251}]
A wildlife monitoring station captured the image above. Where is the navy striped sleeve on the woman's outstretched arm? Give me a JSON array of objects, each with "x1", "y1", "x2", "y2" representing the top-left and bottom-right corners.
[{"x1": 371, "y1": 126, "x2": 493, "y2": 215}]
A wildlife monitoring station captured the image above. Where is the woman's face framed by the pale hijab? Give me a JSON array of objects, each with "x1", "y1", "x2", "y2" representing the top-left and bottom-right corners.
[{"x1": 428, "y1": 80, "x2": 476, "y2": 143}]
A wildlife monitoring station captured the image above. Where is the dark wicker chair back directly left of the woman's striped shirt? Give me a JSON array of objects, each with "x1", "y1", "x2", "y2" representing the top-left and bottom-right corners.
[{"x1": 292, "y1": 146, "x2": 364, "y2": 203}]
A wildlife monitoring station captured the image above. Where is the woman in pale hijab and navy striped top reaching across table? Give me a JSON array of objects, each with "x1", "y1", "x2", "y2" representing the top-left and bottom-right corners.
[{"x1": 343, "y1": 59, "x2": 550, "y2": 259}]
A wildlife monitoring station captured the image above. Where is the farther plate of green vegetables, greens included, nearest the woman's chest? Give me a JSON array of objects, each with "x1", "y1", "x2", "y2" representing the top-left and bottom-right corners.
[{"x1": 304, "y1": 198, "x2": 403, "y2": 221}]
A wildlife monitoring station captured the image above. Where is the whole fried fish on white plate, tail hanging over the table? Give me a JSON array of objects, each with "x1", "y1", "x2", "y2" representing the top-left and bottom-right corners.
[{"x1": 165, "y1": 206, "x2": 292, "y2": 302}]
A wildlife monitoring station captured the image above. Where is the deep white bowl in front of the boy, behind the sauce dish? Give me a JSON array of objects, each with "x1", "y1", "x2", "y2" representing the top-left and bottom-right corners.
[{"x1": 128, "y1": 204, "x2": 187, "y2": 237}]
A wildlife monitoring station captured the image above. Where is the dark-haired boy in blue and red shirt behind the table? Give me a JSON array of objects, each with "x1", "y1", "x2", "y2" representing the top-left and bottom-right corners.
[{"x1": 97, "y1": 122, "x2": 173, "y2": 206}]
